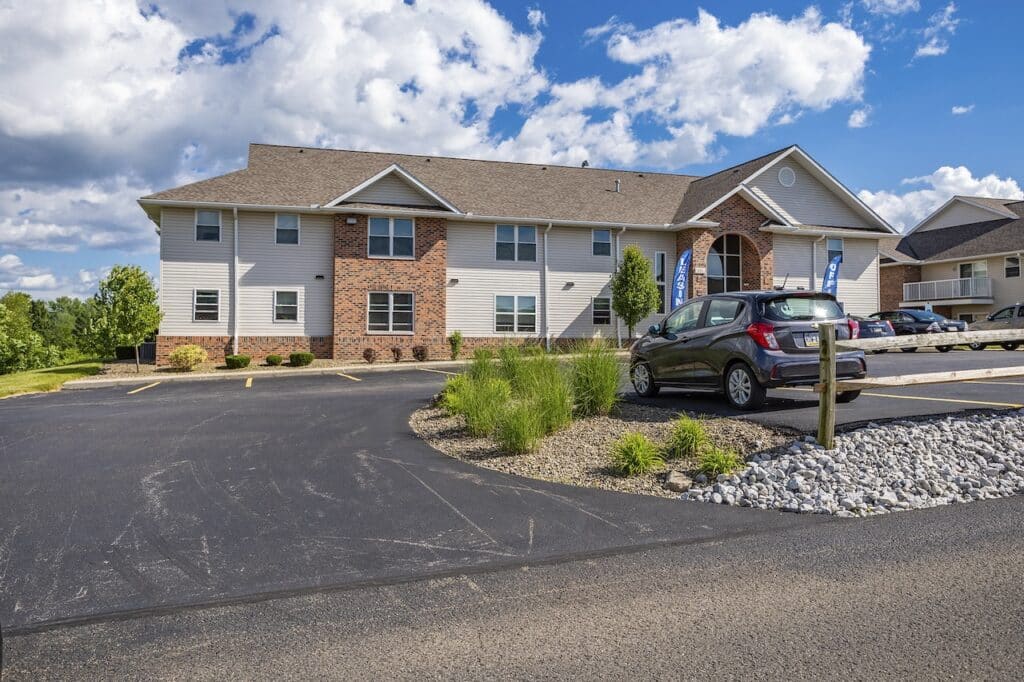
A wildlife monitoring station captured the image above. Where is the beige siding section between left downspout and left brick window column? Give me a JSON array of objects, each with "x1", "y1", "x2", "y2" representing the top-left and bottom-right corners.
[{"x1": 235, "y1": 211, "x2": 334, "y2": 336}]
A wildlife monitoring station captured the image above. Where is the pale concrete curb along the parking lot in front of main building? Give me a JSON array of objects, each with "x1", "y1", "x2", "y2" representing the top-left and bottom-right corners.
[{"x1": 61, "y1": 351, "x2": 629, "y2": 390}]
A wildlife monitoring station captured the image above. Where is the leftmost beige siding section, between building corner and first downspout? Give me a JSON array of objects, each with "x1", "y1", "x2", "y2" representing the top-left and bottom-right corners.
[{"x1": 160, "y1": 209, "x2": 233, "y2": 336}]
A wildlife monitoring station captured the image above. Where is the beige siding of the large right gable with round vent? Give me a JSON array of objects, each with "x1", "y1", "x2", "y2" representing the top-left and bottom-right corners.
[{"x1": 751, "y1": 157, "x2": 869, "y2": 227}]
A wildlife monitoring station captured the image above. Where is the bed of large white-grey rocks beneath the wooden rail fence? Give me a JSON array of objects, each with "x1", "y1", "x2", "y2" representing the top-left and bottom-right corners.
[{"x1": 681, "y1": 411, "x2": 1024, "y2": 516}]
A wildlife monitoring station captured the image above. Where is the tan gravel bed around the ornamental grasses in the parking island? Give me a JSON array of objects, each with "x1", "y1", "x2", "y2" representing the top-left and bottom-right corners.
[{"x1": 410, "y1": 402, "x2": 793, "y2": 498}]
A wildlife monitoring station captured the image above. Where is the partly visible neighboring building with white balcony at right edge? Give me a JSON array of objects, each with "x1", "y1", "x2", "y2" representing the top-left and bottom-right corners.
[{"x1": 881, "y1": 197, "x2": 1024, "y2": 323}]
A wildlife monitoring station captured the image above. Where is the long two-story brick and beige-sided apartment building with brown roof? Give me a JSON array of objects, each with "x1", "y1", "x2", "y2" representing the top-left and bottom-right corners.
[{"x1": 139, "y1": 144, "x2": 895, "y2": 361}]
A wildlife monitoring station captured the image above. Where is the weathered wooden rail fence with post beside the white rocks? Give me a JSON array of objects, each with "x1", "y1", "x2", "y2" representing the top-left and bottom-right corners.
[{"x1": 814, "y1": 323, "x2": 1024, "y2": 450}]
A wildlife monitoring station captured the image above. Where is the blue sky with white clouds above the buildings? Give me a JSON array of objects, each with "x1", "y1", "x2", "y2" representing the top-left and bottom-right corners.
[{"x1": 0, "y1": 0, "x2": 1024, "y2": 297}]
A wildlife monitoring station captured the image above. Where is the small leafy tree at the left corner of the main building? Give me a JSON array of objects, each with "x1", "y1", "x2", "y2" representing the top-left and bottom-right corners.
[{"x1": 92, "y1": 265, "x2": 163, "y2": 371}]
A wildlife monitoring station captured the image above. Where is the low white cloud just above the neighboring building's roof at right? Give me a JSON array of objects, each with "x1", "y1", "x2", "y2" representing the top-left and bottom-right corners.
[{"x1": 857, "y1": 166, "x2": 1024, "y2": 230}]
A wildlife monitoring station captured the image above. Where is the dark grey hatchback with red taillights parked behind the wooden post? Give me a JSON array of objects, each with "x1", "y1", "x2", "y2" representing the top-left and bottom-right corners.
[{"x1": 630, "y1": 291, "x2": 867, "y2": 410}]
